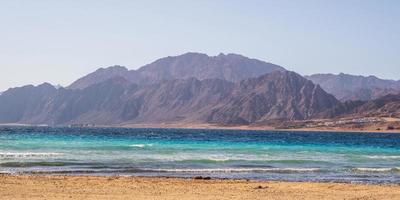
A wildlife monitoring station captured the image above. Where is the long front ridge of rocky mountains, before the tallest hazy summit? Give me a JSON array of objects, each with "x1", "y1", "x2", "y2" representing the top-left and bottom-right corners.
[{"x1": 0, "y1": 71, "x2": 341, "y2": 125}]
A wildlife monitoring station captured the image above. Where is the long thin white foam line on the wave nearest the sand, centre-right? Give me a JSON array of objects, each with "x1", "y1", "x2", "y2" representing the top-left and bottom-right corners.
[{"x1": 146, "y1": 168, "x2": 321, "y2": 173}]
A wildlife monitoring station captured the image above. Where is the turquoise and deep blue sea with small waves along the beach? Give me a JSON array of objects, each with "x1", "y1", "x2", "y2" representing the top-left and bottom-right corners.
[{"x1": 0, "y1": 127, "x2": 400, "y2": 183}]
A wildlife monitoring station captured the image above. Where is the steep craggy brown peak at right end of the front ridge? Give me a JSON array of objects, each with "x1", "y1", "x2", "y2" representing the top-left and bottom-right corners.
[{"x1": 208, "y1": 71, "x2": 340, "y2": 124}]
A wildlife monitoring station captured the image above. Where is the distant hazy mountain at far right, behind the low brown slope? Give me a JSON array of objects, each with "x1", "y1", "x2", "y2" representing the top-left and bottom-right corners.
[{"x1": 306, "y1": 73, "x2": 400, "y2": 101}]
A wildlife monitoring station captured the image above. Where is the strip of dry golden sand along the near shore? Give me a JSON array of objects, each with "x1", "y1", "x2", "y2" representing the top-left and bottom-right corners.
[{"x1": 0, "y1": 175, "x2": 400, "y2": 200}]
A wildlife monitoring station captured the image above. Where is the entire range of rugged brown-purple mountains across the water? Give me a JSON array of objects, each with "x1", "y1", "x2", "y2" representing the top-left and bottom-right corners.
[{"x1": 0, "y1": 53, "x2": 400, "y2": 126}]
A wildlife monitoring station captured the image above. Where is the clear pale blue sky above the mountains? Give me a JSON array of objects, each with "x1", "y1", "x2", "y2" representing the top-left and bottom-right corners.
[{"x1": 0, "y1": 0, "x2": 400, "y2": 91}]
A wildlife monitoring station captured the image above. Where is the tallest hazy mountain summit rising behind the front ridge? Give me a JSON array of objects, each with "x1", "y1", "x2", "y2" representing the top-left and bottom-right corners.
[{"x1": 68, "y1": 53, "x2": 285, "y2": 89}]
